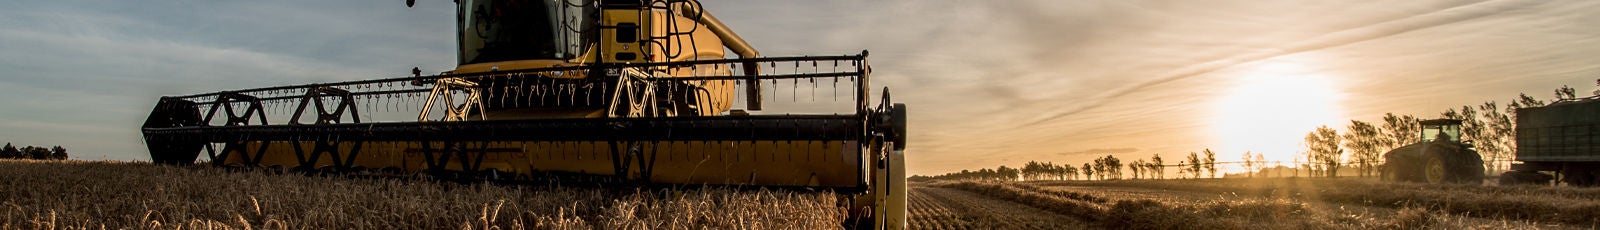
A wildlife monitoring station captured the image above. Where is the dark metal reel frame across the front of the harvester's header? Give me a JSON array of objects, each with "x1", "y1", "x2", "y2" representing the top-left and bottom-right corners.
[{"x1": 142, "y1": 53, "x2": 904, "y2": 185}]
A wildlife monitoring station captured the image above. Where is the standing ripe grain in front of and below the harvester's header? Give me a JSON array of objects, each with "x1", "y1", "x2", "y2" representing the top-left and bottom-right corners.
[{"x1": 0, "y1": 160, "x2": 845, "y2": 230}]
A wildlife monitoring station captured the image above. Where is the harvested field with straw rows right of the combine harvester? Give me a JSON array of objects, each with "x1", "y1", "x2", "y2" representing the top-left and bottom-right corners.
[{"x1": 909, "y1": 177, "x2": 1600, "y2": 228}]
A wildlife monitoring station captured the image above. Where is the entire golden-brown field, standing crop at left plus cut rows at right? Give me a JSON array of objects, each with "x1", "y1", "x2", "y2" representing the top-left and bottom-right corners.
[{"x1": 0, "y1": 161, "x2": 1600, "y2": 230}]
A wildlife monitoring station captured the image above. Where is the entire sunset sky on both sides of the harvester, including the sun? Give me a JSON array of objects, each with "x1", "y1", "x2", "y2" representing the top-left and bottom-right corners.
[{"x1": 0, "y1": 0, "x2": 1600, "y2": 174}]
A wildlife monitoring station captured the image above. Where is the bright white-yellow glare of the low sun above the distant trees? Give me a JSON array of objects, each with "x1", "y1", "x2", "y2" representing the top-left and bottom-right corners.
[{"x1": 1211, "y1": 61, "x2": 1341, "y2": 173}]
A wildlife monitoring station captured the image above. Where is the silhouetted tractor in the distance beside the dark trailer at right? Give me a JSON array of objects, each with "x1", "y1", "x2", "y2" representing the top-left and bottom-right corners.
[{"x1": 1381, "y1": 120, "x2": 1483, "y2": 184}]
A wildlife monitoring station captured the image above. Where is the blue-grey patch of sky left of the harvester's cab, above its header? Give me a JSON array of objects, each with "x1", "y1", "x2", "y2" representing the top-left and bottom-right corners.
[{"x1": 0, "y1": 2, "x2": 454, "y2": 160}]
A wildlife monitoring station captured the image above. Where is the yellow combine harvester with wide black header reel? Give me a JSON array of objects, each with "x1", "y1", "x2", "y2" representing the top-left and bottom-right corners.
[{"x1": 142, "y1": 0, "x2": 906, "y2": 228}]
